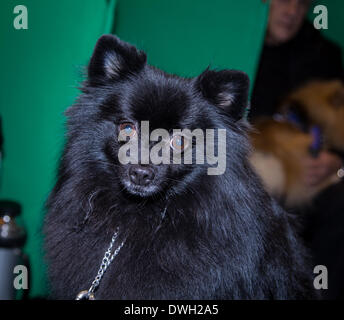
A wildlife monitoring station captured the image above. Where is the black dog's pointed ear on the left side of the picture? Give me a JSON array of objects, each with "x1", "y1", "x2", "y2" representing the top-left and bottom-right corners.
[{"x1": 88, "y1": 35, "x2": 147, "y2": 85}]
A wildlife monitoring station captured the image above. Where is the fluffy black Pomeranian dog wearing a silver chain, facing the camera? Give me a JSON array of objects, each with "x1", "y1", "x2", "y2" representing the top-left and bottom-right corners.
[{"x1": 44, "y1": 35, "x2": 313, "y2": 299}]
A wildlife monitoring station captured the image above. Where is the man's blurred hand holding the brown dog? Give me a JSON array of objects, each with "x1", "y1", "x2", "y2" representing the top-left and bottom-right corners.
[{"x1": 302, "y1": 151, "x2": 343, "y2": 186}]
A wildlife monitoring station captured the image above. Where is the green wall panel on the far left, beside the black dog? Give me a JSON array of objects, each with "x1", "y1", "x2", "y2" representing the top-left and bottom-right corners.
[{"x1": 0, "y1": 0, "x2": 114, "y2": 296}]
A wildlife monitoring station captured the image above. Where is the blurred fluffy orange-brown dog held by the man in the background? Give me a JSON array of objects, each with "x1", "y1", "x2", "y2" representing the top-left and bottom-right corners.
[{"x1": 251, "y1": 80, "x2": 344, "y2": 206}]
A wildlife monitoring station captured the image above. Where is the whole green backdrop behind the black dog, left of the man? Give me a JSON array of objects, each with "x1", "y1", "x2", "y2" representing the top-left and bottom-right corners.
[{"x1": 0, "y1": 0, "x2": 288, "y2": 296}]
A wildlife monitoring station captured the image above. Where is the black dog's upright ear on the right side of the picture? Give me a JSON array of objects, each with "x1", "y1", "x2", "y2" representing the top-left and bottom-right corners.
[{"x1": 196, "y1": 69, "x2": 250, "y2": 120}]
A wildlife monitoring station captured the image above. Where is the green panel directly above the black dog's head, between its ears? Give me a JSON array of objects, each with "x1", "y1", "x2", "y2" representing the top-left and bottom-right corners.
[{"x1": 114, "y1": 0, "x2": 268, "y2": 84}]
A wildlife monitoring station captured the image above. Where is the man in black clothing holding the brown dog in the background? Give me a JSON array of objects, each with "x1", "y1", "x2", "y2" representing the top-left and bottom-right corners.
[{"x1": 249, "y1": 0, "x2": 344, "y2": 299}]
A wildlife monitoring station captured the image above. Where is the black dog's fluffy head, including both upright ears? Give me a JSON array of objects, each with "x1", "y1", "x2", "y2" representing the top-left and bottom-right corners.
[{"x1": 67, "y1": 35, "x2": 248, "y2": 198}]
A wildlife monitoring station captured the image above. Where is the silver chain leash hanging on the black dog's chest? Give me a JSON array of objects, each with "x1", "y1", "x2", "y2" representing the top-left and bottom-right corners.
[{"x1": 75, "y1": 229, "x2": 124, "y2": 300}]
